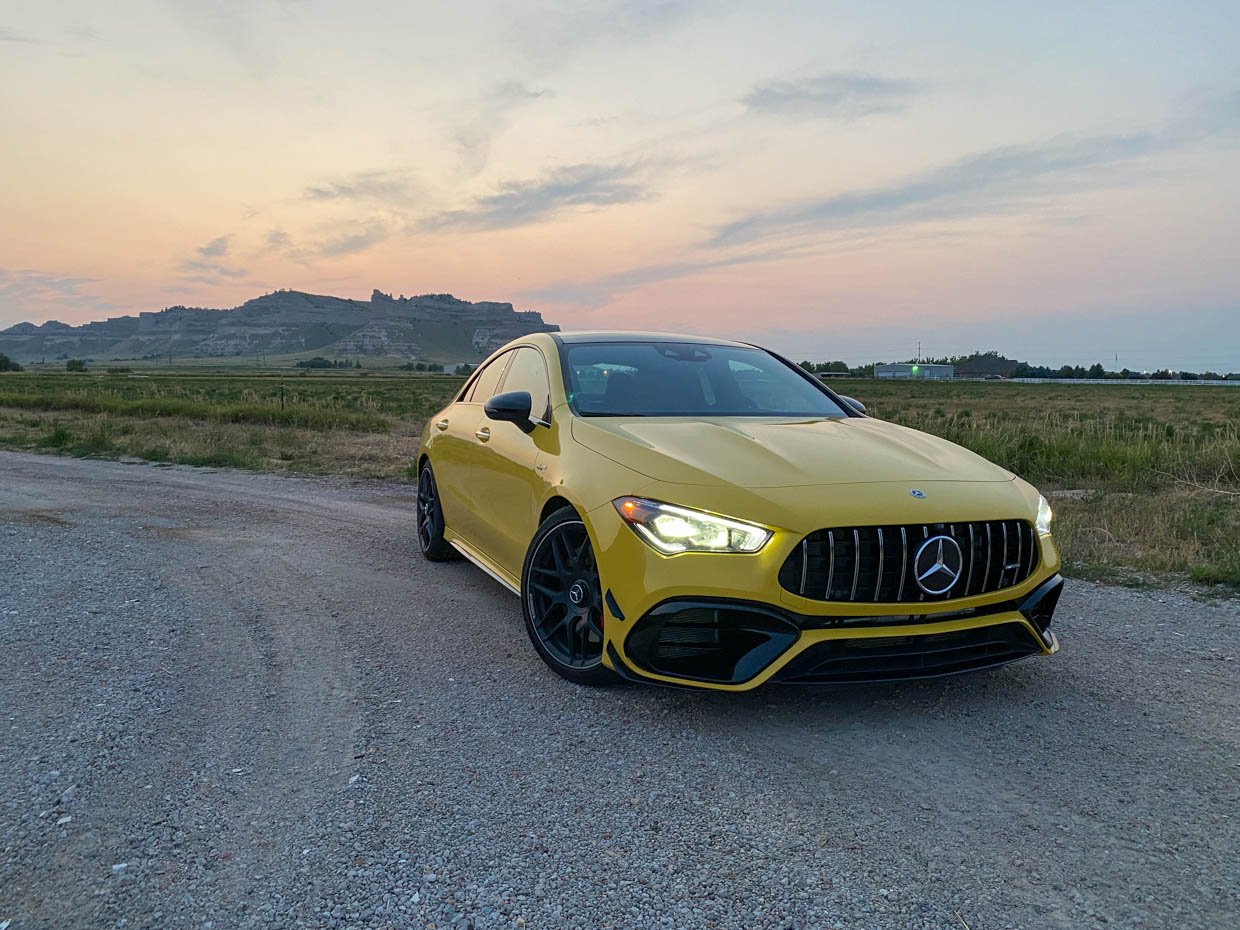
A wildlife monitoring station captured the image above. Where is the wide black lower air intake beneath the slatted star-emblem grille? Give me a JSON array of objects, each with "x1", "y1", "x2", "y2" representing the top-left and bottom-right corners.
[{"x1": 775, "y1": 624, "x2": 1042, "y2": 684}]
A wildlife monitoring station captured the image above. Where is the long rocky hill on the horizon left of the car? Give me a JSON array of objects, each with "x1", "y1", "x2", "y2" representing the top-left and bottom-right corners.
[{"x1": 0, "y1": 290, "x2": 559, "y2": 362}]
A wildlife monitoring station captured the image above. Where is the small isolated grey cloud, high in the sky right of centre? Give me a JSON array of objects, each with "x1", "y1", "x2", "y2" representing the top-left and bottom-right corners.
[{"x1": 742, "y1": 72, "x2": 920, "y2": 120}]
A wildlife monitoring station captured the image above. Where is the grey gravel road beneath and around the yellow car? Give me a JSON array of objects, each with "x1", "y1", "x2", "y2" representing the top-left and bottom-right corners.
[{"x1": 0, "y1": 453, "x2": 1240, "y2": 930}]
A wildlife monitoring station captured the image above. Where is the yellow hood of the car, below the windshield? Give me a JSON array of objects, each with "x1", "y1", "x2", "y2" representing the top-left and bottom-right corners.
[{"x1": 572, "y1": 417, "x2": 1013, "y2": 487}]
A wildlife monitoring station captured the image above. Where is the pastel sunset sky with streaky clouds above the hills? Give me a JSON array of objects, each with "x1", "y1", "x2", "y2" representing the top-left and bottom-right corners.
[{"x1": 0, "y1": 0, "x2": 1240, "y2": 371}]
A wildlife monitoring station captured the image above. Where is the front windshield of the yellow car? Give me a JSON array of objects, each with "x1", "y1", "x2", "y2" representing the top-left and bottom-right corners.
[{"x1": 564, "y1": 342, "x2": 848, "y2": 417}]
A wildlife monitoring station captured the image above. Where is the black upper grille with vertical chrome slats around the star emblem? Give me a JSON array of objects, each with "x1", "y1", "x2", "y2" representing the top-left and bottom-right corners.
[{"x1": 779, "y1": 520, "x2": 1038, "y2": 604}]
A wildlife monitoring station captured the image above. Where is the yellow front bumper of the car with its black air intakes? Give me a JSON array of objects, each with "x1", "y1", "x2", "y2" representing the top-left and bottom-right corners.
[{"x1": 594, "y1": 505, "x2": 1063, "y2": 691}]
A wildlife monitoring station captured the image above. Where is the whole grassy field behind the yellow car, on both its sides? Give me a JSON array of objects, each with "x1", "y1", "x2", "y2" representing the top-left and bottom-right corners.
[{"x1": 0, "y1": 371, "x2": 1240, "y2": 588}]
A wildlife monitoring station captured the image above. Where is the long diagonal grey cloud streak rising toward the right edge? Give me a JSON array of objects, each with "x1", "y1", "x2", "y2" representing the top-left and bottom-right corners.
[{"x1": 708, "y1": 133, "x2": 1174, "y2": 246}]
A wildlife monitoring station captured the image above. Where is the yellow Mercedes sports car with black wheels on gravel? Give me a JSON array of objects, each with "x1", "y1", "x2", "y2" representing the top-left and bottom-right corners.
[{"x1": 418, "y1": 332, "x2": 1063, "y2": 691}]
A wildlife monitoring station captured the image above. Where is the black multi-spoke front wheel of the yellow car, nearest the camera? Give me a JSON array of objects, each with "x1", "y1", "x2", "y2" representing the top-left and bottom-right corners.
[{"x1": 521, "y1": 507, "x2": 619, "y2": 684}]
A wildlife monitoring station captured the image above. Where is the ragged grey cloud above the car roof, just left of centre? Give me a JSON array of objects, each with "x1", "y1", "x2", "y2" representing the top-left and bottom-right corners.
[{"x1": 414, "y1": 165, "x2": 651, "y2": 231}]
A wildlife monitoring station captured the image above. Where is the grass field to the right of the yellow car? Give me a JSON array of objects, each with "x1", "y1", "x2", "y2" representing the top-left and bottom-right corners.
[{"x1": 839, "y1": 382, "x2": 1240, "y2": 588}]
